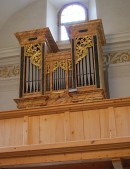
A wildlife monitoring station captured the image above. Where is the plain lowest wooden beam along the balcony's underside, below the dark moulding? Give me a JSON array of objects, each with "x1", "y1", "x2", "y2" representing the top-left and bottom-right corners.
[{"x1": 0, "y1": 148, "x2": 130, "y2": 169}]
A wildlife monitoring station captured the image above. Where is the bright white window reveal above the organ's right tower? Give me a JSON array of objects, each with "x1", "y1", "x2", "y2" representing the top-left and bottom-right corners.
[{"x1": 88, "y1": 0, "x2": 97, "y2": 20}]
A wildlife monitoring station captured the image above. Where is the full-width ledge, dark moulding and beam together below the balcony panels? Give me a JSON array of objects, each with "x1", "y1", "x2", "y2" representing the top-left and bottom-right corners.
[{"x1": 0, "y1": 138, "x2": 130, "y2": 167}]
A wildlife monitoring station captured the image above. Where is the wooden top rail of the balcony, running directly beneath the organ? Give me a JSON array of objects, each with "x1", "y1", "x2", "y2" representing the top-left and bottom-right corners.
[{"x1": 0, "y1": 97, "x2": 130, "y2": 119}]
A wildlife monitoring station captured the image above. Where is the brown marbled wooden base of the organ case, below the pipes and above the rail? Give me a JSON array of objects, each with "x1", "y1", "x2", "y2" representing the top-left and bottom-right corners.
[{"x1": 14, "y1": 86, "x2": 105, "y2": 109}]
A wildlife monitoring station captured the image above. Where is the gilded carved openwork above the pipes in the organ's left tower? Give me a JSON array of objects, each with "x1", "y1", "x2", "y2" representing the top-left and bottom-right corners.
[{"x1": 25, "y1": 44, "x2": 42, "y2": 69}]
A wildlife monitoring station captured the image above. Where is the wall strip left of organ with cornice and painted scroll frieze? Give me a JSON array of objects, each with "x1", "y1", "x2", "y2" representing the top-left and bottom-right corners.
[{"x1": 0, "y1": 47, "x2": 20, "y2": 111}]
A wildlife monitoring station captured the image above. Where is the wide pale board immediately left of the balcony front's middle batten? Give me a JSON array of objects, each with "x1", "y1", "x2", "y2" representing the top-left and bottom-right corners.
[{"x1": 40, "y1": 114, "x2": 65, "y2": 144}]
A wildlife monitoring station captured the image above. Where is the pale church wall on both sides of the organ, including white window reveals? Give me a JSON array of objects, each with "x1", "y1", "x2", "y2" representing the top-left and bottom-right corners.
[{"x1": 0, "y1": 0, "x2": 130, "y2": 111}]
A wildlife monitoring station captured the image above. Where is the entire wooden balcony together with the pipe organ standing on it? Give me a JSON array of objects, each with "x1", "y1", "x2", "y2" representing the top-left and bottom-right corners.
[{"x1": 0, "y1": 19, "x2": 130, "y2": 169}]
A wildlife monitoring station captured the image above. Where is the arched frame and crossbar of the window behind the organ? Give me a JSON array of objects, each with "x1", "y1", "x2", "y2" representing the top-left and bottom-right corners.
[{"x1": 58, "y1": 2, "x2": 89, "y2": 41}]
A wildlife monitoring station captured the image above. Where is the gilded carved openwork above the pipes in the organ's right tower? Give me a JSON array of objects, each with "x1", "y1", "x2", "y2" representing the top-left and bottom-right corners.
[{"x1": 75, "y1": 35, "x2": 93, "y2": 64}]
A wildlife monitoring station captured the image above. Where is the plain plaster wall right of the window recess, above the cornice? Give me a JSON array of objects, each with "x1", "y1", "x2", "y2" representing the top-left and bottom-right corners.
[{"x1": 96, "y1": 0, "x2": 130, "y2": 34}]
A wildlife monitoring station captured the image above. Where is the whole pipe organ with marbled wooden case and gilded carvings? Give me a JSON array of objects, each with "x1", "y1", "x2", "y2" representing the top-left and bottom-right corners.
[{"x1": 15, "y1": 20, "x2": 105, "y2": 108}]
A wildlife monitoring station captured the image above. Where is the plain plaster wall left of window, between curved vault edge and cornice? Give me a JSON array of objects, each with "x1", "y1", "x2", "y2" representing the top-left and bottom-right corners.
[{"x1": 0, "y1": 0, "x2": 47, "y2": 48}]
